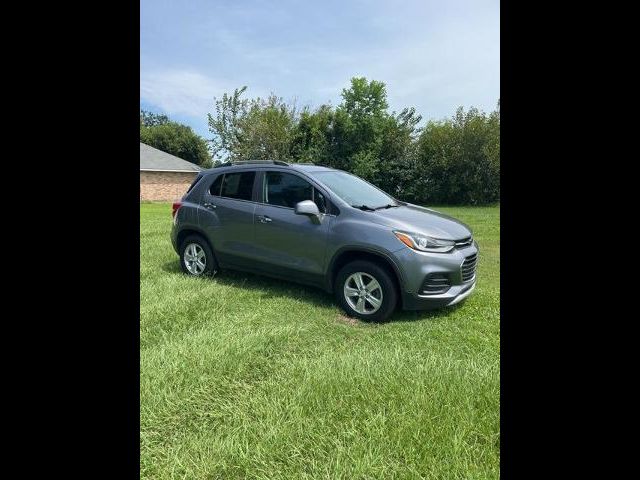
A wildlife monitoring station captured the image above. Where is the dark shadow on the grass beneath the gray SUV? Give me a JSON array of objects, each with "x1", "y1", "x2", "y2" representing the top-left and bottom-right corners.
[{"x1": 162, "y1": 260, "x2": 466, "y2": 324}]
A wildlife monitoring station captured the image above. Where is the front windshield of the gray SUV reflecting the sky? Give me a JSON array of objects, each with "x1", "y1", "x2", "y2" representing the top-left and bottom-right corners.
[{"x1": 312, "y1": 171, "x2": 397, "y2": 210}]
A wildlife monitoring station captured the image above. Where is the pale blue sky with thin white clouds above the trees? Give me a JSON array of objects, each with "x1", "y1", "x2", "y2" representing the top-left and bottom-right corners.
[{"x1": 140, "y1": 0, "x2": 500, "y2": 138}]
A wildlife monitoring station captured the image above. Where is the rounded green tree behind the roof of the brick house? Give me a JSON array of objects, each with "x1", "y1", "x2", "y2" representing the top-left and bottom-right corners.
[{"x1": 140, "y1": 111, "x2": 211, "y2": 168}]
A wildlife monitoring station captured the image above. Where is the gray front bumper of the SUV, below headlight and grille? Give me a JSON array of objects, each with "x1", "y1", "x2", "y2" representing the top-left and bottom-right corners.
[{"x1": 394, "y1": 242, "x2": 478, "y2": 310}]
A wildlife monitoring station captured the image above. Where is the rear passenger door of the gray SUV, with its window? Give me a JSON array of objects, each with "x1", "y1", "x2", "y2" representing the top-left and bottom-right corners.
[{"x1": 198, "y1": 170, "x2": 257, "y2": 266}]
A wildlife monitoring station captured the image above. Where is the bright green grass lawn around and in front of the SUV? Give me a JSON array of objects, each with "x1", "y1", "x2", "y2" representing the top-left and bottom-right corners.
[{"x1": 140, "y1": 204, "x2": 500, "y2": 479}]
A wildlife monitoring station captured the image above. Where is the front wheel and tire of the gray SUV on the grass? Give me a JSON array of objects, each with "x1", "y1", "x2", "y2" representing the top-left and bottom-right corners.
[{"x1": 334, "y1": 260, "x2": 398, "y2": 322}]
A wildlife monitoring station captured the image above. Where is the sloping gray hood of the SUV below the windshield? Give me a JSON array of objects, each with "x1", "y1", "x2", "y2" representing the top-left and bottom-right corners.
[{"x1": 365, "y1": 203, "x2": 471, "y2": 240}]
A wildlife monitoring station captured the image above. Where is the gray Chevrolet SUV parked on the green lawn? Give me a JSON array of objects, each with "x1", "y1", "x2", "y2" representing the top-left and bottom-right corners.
[{"x1": 171, "y1": 161, "x2": 478, "y2": 321}]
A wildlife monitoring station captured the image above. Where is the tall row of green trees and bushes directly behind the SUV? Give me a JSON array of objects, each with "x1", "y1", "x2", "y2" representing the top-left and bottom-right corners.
[{"x1": 141, "y1": 78, "x2": 500, "y2": 205}]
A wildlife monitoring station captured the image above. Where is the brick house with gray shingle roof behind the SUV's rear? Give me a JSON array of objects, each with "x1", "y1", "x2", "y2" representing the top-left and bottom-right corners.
[{"x1": 140, "y1": 142, "x2": 201, "y2": 201}]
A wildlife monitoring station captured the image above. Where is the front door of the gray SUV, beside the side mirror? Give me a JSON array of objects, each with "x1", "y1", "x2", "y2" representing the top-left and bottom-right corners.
[{"x1": 255, "y1": 170, "x2": 332, "y2": 277}]
